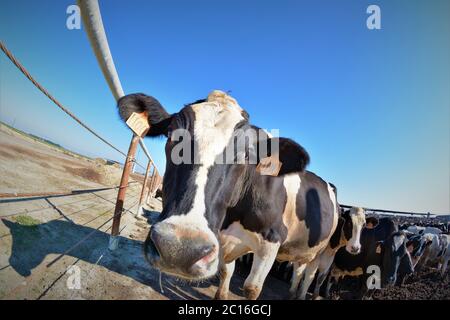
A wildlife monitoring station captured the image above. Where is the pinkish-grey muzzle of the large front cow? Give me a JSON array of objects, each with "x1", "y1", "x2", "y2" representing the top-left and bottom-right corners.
[{"x1": 144, "y1": 222, "x2": 219, "y2": 280}]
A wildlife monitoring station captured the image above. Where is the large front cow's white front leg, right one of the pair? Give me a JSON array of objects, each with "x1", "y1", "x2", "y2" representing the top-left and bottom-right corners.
[{"x1": 244, "y1": 241, "x2": 280, "y2": 300}]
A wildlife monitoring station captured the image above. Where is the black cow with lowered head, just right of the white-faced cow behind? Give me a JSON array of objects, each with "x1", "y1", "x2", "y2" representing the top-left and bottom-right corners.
[{"x1": 326, "y1": 218, "x2": 414, "y2": 297}]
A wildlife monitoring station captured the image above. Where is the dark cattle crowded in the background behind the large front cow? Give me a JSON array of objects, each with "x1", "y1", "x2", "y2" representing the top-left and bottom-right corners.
[{"x1": 256, "y1": 210, "x2": 450, "y2": 298}]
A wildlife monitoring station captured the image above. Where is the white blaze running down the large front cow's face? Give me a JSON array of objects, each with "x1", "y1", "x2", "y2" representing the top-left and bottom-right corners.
[{"x1": 166, "y1": 91, "x2": 244, "y2": 276}]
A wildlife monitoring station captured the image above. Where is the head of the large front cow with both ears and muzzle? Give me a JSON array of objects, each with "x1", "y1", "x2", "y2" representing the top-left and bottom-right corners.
[{"x1": 118, "y1": 91, "x2": 309, "y2": 280}]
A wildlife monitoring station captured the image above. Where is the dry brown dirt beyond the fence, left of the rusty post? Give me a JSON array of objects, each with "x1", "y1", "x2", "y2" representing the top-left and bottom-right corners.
[{"x1": 0, "y1": 124, "x2": 125, "y2": 194}]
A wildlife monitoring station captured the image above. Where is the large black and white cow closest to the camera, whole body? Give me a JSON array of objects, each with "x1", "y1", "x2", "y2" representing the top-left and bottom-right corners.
[{"x1": 118, "y1": 91, "x2": 339, "y2": 299}]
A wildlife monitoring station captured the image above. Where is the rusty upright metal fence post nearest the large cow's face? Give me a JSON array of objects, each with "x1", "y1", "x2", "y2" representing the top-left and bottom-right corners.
[{"x1": 109, "y1": 134, "x2": 139, "y2": 250}]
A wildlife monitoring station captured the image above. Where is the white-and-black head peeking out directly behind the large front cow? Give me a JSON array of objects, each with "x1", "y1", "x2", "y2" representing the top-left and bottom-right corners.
[{"x1": 342, "y1": 207, "x2": 366, "y2": 254}]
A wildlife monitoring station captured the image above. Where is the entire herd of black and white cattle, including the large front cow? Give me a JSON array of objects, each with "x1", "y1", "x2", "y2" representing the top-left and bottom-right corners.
[{"x1": 118, "y1": 91, "x2": 450, "y2": 299}]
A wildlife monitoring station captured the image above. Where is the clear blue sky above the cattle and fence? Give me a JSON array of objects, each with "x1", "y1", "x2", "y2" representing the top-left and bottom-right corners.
[{"x1": 0, "y1": 0, "x2": 450, "y2": 213}]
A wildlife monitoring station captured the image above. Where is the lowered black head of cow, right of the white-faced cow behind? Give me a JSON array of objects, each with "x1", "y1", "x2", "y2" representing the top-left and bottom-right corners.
[{"x1": 376, "y1": 231, "x2": 414, "y2": 287}]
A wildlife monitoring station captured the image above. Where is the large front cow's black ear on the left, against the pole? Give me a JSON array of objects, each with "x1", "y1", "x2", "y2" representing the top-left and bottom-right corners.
[{"x1": 117, "y1": 93, "x2": 171, "y2": 137}]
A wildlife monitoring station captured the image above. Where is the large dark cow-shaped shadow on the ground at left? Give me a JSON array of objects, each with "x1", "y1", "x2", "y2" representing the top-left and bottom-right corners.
[{"x1": 2, "y1": 215, "x2": 211, "y2": 299}]
